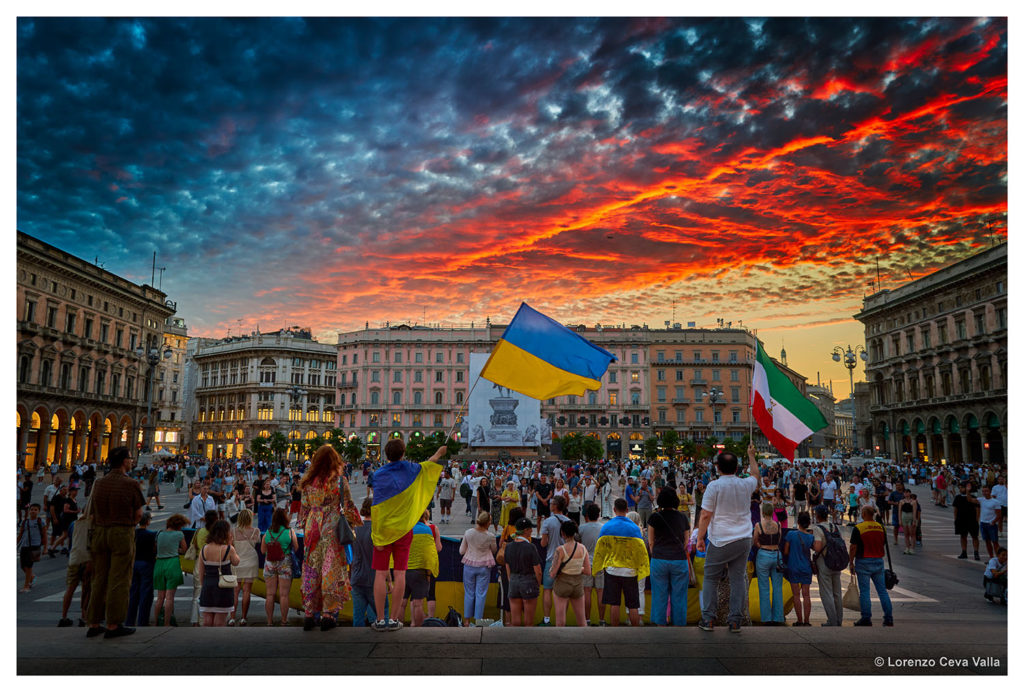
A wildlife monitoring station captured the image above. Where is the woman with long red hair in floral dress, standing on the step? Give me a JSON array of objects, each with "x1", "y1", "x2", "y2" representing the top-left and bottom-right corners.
[{"x1": 299, "y1": 444, "x2": 362, "y2": 632}]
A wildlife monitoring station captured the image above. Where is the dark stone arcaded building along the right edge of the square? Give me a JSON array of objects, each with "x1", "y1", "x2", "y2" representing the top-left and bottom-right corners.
[{"x1": 855, "y1": 244, "x2": 1008, "y2": 464}]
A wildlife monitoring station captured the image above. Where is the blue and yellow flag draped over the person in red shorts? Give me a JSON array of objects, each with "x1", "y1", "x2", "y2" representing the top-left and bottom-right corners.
[{"x1": 370, "y1": 461, "x2": 441, "y2": 546}]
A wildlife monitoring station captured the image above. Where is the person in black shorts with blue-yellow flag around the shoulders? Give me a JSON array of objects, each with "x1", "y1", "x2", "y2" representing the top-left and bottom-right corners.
[{"x1": 592, "y1": 498, "x2": 650, "y2": 628}]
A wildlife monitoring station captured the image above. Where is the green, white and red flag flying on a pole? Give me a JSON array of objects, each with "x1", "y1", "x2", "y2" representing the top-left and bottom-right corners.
[{"x1": 751, "y1": 343, "x2": 828, "y2": 462}]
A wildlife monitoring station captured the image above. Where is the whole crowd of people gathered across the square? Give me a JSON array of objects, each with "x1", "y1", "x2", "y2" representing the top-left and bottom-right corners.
[{"x1": 17, "y1": 440, "x2": 1008, "y2": 638}]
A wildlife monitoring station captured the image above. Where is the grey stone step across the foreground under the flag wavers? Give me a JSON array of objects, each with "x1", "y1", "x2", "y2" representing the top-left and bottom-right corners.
[{"x1": 17, "y1": 621, "x2": 1008, "y2": 676}]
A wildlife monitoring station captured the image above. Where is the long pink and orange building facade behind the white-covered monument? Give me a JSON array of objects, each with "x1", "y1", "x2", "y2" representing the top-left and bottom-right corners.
[{"x1": 336, "y1": 322, "x2": 790, "y2": 459}]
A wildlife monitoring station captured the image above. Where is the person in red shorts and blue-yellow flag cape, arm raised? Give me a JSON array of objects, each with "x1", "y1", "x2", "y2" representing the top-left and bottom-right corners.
[{"x1": 370, "y1": 439, "x2": 447, "y2": 632}]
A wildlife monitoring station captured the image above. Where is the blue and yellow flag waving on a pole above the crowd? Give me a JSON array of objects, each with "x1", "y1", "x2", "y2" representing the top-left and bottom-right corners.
[{"x1": 480, "y1": 303, "x2": 615, "y2": 399}]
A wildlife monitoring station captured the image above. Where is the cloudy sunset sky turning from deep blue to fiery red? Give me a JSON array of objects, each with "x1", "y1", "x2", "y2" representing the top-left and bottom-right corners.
[{"x1": 17, "y1": 18, "x2": 1008, "y2": 396}]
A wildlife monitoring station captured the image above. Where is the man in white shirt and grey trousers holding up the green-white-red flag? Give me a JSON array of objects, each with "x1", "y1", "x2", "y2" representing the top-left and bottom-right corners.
[{"x1": 697, "y1": 444, "x2": 761, "y2": 633}]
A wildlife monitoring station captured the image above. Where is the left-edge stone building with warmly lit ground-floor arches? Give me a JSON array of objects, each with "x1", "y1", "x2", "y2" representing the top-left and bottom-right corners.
[{"x1": 16, "y1": 231, "x2": 176, "y2": 469}]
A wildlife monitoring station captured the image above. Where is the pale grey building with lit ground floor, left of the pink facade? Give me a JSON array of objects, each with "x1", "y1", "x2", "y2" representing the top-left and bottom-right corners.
[{"x1": 183, "y1": 328, "x2": 338, "y2": 459}]
